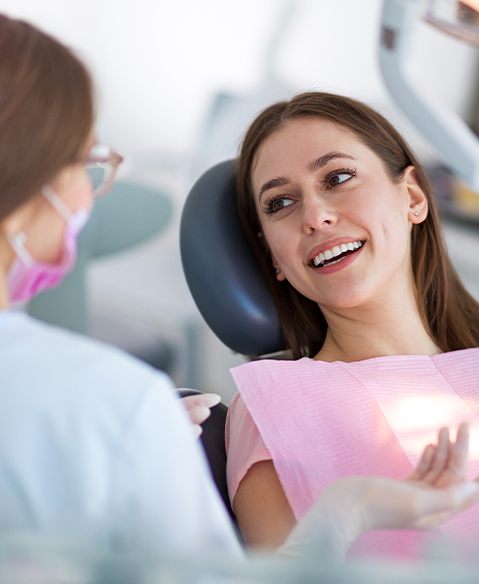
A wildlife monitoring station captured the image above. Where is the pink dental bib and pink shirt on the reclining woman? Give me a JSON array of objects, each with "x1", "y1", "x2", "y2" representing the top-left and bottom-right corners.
[{"x1": 226, "y1": 349, "x2": 479, "y2": 557}]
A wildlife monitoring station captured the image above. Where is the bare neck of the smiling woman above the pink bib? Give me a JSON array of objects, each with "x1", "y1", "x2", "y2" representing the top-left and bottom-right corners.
[{"x1": 315, "y1": 280, "x2": 441, "y2": 361}]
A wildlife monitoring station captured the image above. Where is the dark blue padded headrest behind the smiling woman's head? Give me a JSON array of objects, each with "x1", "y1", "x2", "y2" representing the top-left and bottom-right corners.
[{"x1": 180, "y1": 160, "x2": 284, "y2": 356}]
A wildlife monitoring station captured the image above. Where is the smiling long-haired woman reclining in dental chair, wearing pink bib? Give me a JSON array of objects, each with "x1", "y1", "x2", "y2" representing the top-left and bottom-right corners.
[{"x1": 227, "y1": 93, "x2": 479, "y2": 556}]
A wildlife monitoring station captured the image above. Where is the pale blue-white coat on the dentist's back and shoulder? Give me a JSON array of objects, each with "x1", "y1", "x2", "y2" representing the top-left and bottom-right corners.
[{"x1": 0, "y1": 311, "x2": 240, "y2": 554}]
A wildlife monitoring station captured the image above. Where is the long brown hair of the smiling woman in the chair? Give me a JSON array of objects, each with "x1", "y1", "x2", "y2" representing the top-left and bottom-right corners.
[{"x1": 237, "y1": 92, "x2": 479, "y2": 357}]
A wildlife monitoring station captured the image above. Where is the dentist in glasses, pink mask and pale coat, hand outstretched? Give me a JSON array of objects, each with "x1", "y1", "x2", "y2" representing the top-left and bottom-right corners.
[{"x1": 0, "y1": 15, "x2": 479, "y2": 557}]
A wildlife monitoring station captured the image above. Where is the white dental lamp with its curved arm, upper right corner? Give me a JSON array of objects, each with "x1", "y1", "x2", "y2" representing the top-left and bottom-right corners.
[{"x1": 379, "y1": 0, "x2": 479, "y2": 191}]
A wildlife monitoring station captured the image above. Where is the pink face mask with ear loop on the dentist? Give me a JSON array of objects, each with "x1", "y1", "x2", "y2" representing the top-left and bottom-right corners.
[{"x1": 7, "y1": 185, "x2": 89, "y2": 302}]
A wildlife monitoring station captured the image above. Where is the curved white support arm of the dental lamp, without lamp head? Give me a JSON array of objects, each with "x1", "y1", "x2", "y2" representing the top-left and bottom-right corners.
[{"x1": 379, "y1": 0, "x2": 479, "y2": 191}]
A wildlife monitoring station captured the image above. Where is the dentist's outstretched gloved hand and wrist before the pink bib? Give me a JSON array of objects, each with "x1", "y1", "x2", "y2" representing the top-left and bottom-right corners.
[{"x1": 278, "y1": 424, "x2": 479, "y2": 560}]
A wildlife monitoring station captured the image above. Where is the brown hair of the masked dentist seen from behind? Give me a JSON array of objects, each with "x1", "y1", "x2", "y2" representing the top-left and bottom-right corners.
[{"x1": 0, "y1": 15, "x2": 94, "y2": 221}]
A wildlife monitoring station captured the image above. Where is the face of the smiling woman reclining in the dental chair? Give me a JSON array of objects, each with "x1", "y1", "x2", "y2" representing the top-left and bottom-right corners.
[{"x1": 252, "y1": 118, "x2": 427, "y2": 309}]
